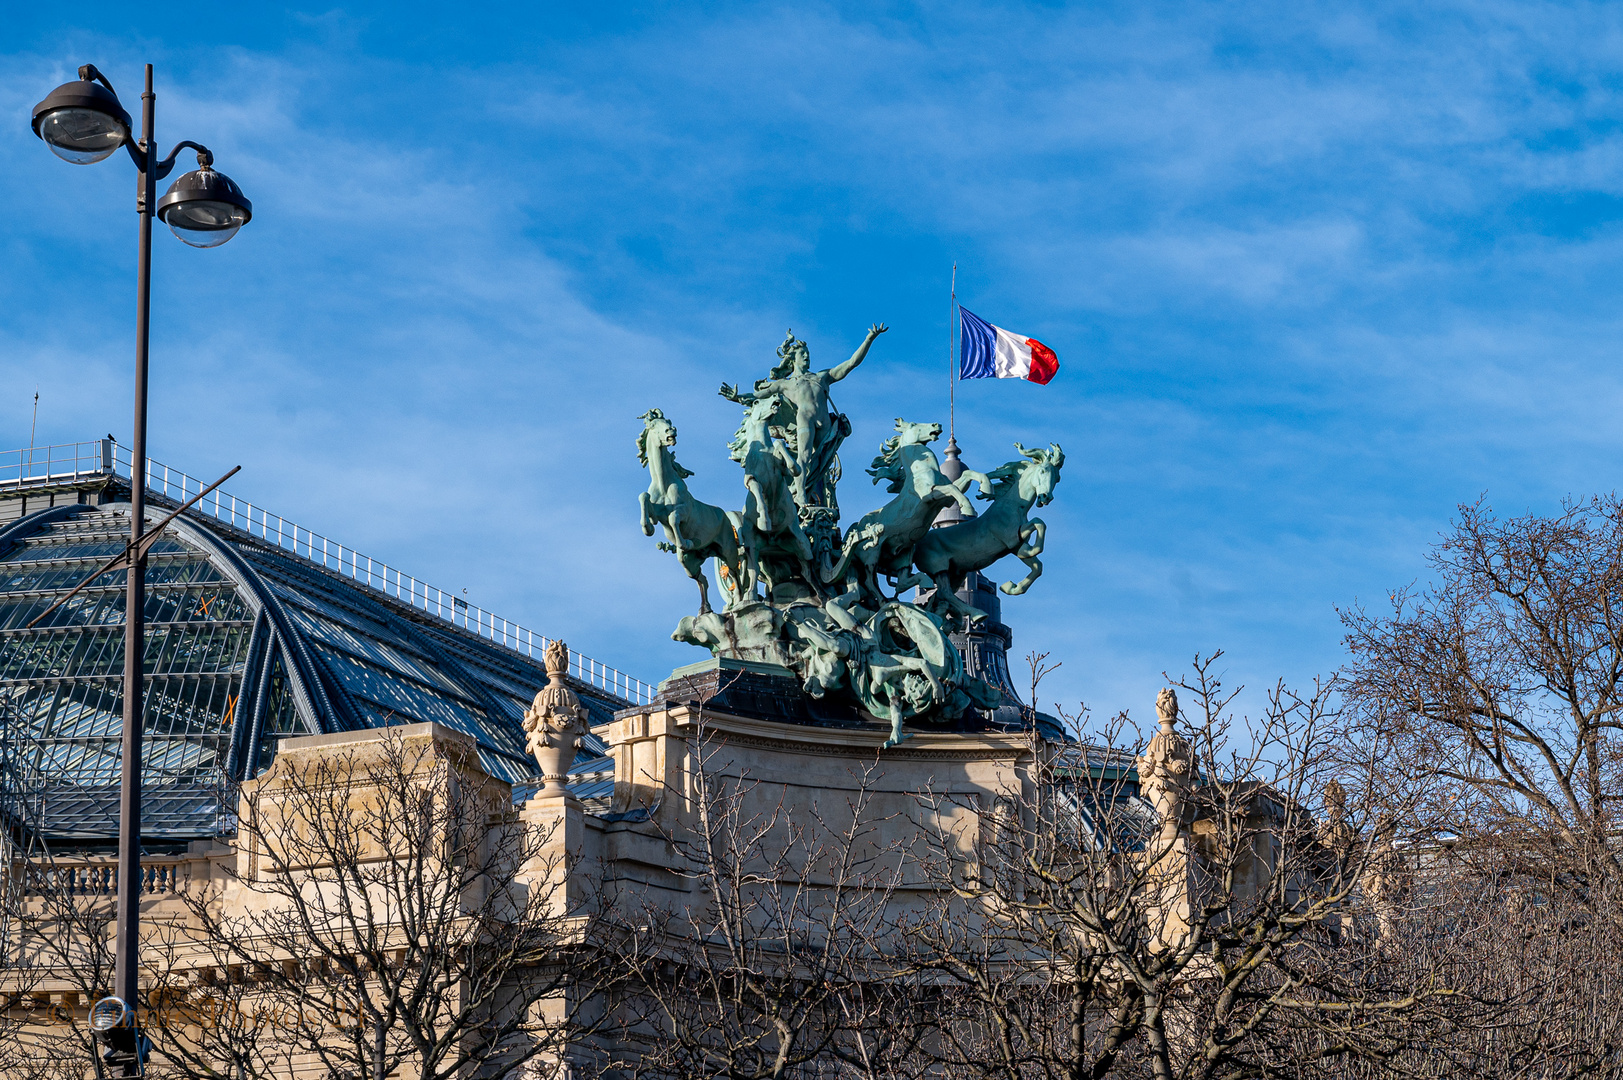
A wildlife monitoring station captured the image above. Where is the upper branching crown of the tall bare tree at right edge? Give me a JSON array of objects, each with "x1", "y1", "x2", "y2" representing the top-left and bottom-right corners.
[{"x1": 1344, "y1": 497, "x2": 1623, "y2": 921}]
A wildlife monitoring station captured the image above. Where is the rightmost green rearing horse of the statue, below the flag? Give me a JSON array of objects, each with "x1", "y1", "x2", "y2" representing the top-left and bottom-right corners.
[{"x1": 896, "y1": 443, "x2": 1065, "y2": 619}]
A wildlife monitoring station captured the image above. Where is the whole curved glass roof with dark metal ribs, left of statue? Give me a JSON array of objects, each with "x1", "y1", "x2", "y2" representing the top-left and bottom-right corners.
[{"x1": 0, "y1": 503, "x2": 630, "y2": 843}]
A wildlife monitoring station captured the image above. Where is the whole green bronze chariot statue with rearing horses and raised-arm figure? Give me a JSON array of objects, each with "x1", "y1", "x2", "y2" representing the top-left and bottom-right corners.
[{"x1": 638, "y1": 323, "x2": 1065, "y2": 747}]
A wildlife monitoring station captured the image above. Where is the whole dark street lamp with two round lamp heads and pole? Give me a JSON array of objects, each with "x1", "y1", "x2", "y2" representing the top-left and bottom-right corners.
[{"x1": 32, "y1": 63, "x2": 253, "y2": 1077}]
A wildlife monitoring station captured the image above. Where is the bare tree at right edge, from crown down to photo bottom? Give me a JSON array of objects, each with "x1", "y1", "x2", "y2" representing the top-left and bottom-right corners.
[{"x1": 1342, "y1": 495, "x2": 1623, "y2": 1077}]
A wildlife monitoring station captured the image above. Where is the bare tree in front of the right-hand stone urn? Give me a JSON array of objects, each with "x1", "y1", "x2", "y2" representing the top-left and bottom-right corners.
[{"x1": 904, "y1": 656, "x2": 1453, "y2": 1080}]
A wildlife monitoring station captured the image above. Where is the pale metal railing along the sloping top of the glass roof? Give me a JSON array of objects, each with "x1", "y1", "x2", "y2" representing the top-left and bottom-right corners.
[{"x1": 0, "y1": 438, "x2": 656, "y2": 705}]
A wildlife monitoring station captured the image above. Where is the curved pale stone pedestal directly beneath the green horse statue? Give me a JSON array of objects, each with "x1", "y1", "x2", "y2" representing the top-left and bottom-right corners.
[{"x1": 600, "y1": 678, "x2": 1040, "y2": 890}]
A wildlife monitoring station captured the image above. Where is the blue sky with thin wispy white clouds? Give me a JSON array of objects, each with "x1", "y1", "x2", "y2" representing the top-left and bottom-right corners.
[{"x1": 0, "y1": 3, "x2": 1623, "y2": 727}]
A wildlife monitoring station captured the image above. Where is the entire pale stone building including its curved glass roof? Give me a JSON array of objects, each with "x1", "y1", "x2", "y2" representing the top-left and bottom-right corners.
[{"x1": 0, "y1": 443, "x2": 1304, "y2": 1078}]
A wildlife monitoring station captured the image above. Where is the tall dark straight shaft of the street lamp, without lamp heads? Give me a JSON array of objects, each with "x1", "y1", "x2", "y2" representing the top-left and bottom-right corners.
[{"x1": 114, "y1": 63, "x2": 157, "y2": 1058}]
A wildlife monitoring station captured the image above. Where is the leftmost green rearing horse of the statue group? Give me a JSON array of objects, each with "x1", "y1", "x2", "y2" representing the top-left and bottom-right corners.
[{"x1": 636, "y1": 409, "x2": 743, "y2": 614}]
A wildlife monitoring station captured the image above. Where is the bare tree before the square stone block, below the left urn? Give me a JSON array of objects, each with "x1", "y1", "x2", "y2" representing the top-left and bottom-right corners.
[{"x1": 174, "y1": 729, "x2": 603, "y2": 1080}]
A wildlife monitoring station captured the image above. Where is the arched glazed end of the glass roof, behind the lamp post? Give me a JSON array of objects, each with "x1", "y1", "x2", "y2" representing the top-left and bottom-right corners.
[{"x1": 0, "y1": 513, "x2": 252, "y2": 840}]
